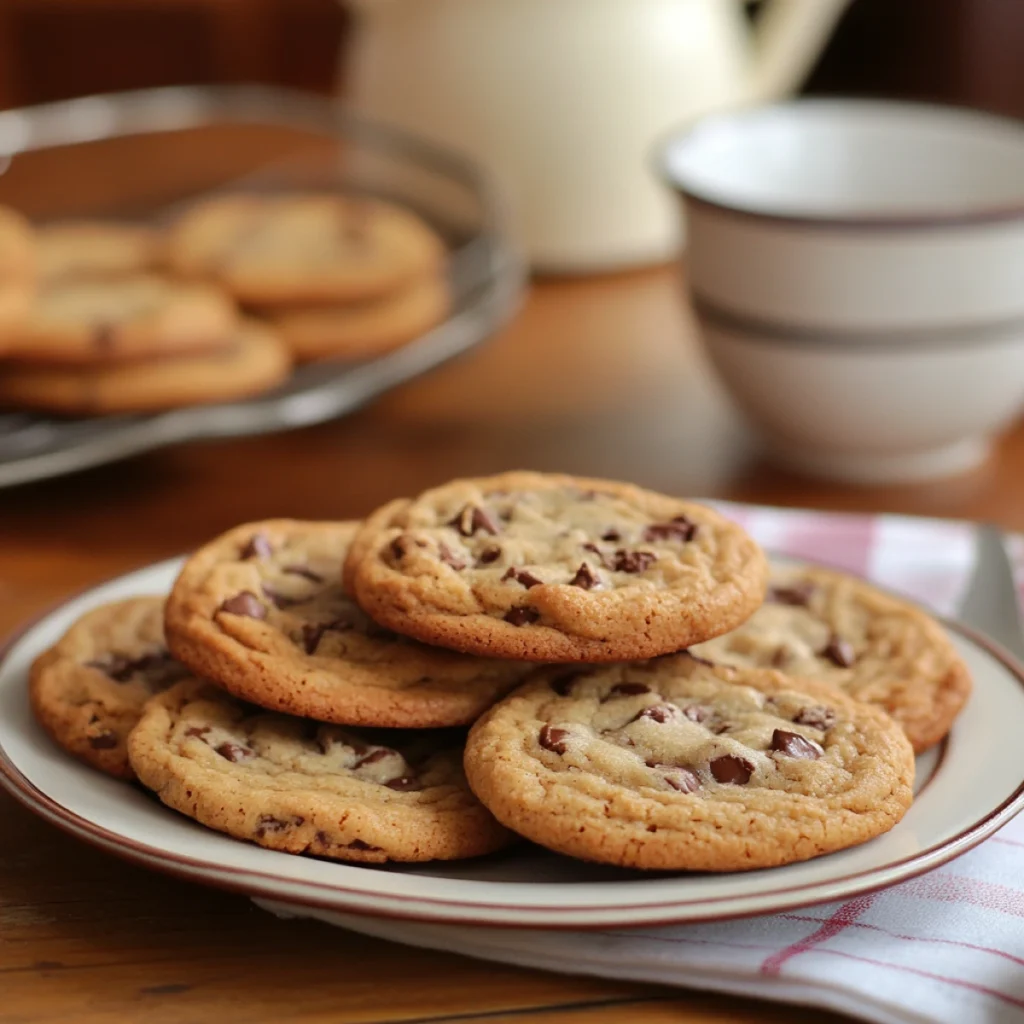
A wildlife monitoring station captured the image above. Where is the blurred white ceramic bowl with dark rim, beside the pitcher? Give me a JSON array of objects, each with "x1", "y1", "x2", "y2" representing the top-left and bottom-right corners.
[{"x1": 662, "y1": 100, "x2": 1024, "y2": 482}]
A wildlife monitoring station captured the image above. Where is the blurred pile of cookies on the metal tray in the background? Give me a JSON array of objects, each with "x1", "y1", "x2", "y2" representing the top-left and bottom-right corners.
[{"x1": 0, "y1": 195, "x2": 447, "y2": 415}]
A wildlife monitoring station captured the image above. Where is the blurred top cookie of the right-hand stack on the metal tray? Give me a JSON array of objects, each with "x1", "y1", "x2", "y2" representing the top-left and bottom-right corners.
[{"x1": 167, "y1": 195, "x2": 444, "y2": 305}]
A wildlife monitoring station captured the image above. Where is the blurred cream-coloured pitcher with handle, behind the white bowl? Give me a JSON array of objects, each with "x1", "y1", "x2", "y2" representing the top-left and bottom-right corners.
[{"x1": 346, "y1": 0, "x2": 848, "y2": 271}]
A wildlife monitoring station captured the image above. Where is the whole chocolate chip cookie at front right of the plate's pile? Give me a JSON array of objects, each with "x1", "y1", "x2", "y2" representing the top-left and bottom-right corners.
[{"x1": 466, "y1": 653, "x2": 914, "y2": 871}]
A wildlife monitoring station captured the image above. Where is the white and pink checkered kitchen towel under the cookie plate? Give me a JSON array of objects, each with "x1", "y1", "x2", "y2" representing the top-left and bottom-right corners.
[{"x1": 327, "y1": 505, "x2": 1024, "y2": 1024}]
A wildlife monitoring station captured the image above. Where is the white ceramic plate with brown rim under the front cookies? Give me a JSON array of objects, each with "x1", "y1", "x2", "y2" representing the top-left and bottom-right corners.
[{"x1": 0, "y1": 561, "x2": 1024, "y2": 928}]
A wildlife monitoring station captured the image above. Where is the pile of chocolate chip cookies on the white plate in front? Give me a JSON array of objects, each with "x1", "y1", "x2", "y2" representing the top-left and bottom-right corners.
[{"x1": 31, "y1": 472, "x2": 971, "y2": 871}]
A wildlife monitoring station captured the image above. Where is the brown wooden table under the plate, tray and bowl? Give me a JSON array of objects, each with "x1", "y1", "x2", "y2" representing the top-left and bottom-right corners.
[{"x1": 0, "y1": 270, "x2": 1024, "y2": 1024}]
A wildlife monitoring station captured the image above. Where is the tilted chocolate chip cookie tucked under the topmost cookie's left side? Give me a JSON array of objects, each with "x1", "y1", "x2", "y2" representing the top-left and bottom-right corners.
[{"x1": 167, "y1": 519, "x2": 528, "y2": 728}]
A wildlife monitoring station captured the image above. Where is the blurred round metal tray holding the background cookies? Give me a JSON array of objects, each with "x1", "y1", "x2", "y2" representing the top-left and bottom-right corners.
[{"x1": 0, "y1": 86, "x2": 525, "y2": 486}]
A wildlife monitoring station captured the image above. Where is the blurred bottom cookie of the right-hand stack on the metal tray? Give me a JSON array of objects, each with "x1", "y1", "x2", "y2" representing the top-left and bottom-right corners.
[{"x1": 269, "y1": 276, "x2": 452, "y2": 362}]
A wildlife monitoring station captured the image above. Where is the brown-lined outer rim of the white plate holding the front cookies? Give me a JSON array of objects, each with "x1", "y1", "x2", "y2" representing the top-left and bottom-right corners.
[{"x1": 0, "y1": 555, "x2": 1024, "y2": 931}]
